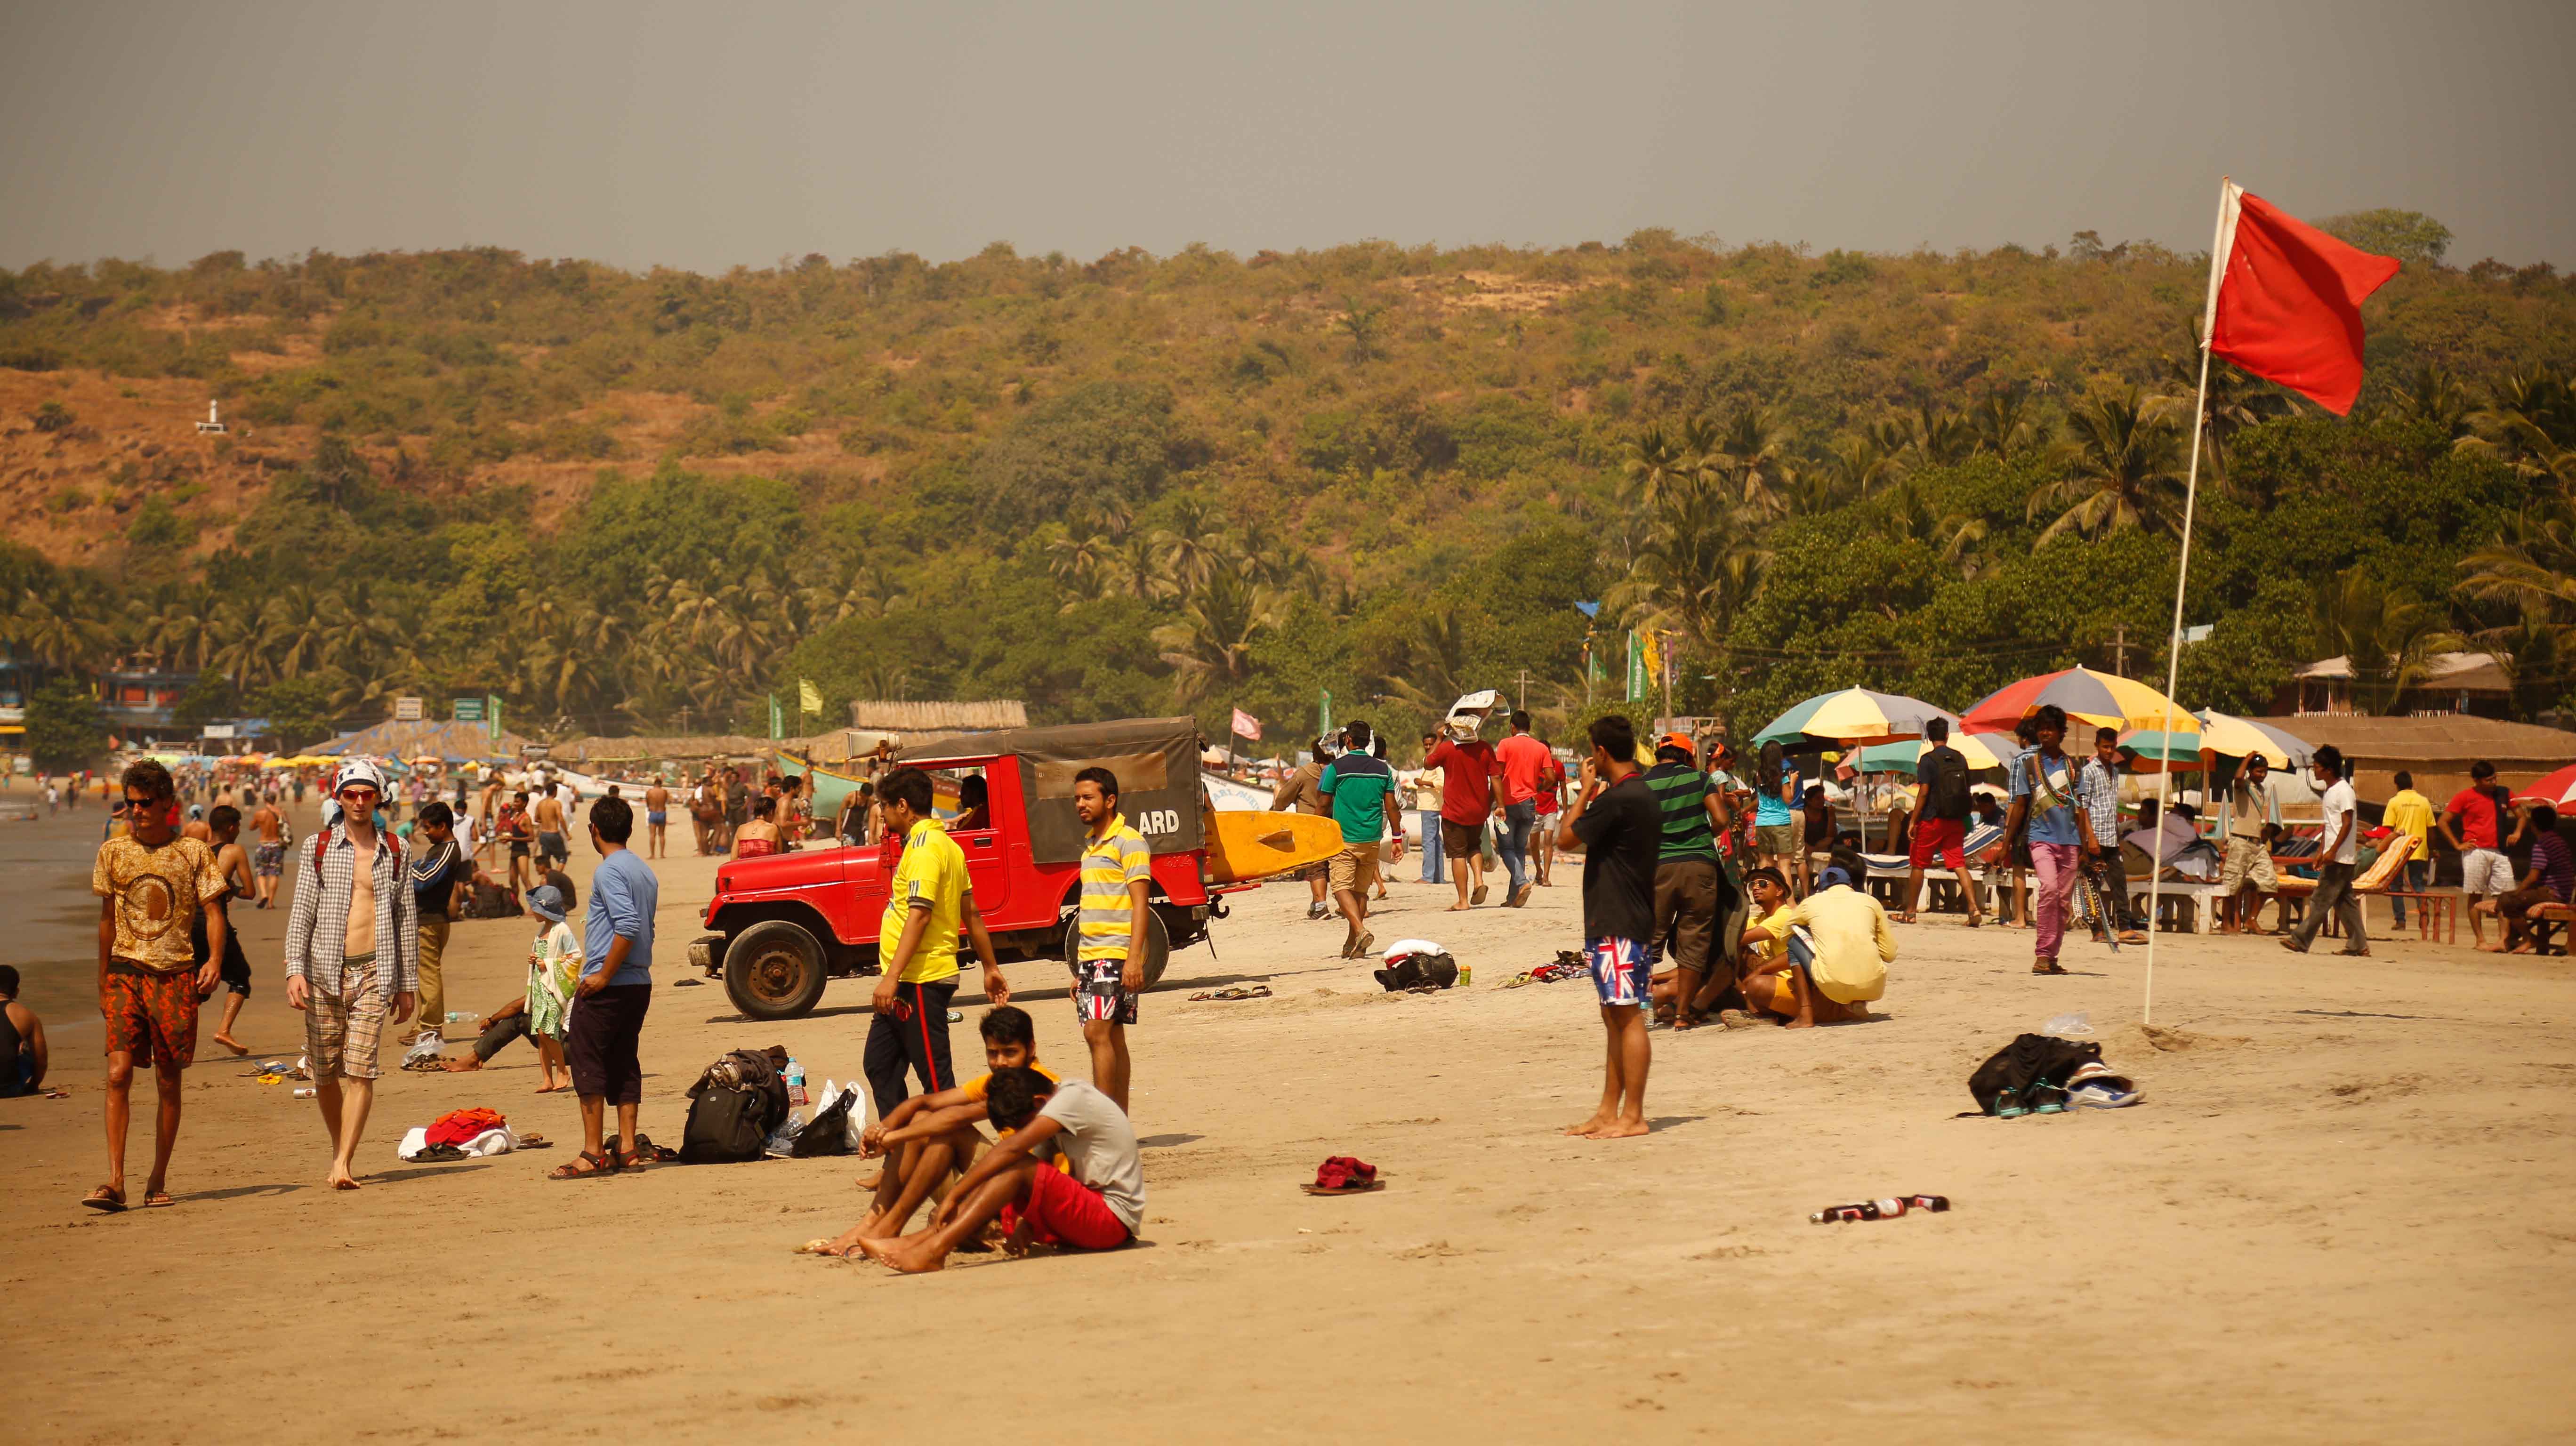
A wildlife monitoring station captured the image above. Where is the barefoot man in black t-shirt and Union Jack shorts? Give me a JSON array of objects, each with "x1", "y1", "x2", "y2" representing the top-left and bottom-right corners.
[{"x1": 1556, "y1": 714, "x2": 1664, "y2": 1139}]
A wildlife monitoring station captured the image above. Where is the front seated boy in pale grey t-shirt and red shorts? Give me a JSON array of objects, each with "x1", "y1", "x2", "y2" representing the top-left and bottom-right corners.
[{"x1": 858, "y1": 1067, "x2": 1144, "y2": 1273}]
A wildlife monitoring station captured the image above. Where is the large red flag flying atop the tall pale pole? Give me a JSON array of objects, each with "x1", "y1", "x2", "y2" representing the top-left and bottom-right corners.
[{"x1": 2203, "y1": 183, "x2": 2398, "y2": 415}]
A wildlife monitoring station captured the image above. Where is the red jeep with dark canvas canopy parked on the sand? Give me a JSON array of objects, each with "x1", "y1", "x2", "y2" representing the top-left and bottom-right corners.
[{"x1": 688, "y1": 719, "x2": 1249, "y2": 1018}]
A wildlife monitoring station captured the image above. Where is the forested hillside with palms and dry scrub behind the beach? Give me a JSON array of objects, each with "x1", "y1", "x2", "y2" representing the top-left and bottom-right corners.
[{"x1": 0, "y1": 211, "x2": 2576, "y2": 742}]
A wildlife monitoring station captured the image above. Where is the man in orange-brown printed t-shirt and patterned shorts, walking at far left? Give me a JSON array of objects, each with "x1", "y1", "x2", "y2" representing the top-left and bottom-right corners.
[{"x1": 80, "y1": 758, "x2": 232, "y2": 1212}]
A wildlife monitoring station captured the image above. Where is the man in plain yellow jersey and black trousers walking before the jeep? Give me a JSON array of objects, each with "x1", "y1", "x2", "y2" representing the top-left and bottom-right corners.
[{"x1": 861, "y1": 768, "x2": 1010, "y2": 1119}]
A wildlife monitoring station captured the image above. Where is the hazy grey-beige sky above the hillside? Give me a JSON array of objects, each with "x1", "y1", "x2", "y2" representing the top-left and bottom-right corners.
[{"x1": 0, "y1": 0, "x2": 2576, "y2": 271}]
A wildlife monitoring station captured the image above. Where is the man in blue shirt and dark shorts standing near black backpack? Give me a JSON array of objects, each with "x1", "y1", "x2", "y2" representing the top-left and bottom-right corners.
[{"x1": 554, "y1": 799, "x2": 662, "y2": 1181}]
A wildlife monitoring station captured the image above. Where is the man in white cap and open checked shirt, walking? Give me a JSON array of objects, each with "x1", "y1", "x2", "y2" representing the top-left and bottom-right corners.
[{"x1": 286, "y1": 760, "x2": 420, "y2": 1191}]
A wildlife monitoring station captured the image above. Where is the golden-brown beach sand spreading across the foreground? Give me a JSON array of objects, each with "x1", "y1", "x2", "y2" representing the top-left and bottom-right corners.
[{"x1": 0, "y1": 827, "x2": 2576, "y2": 1444}]
